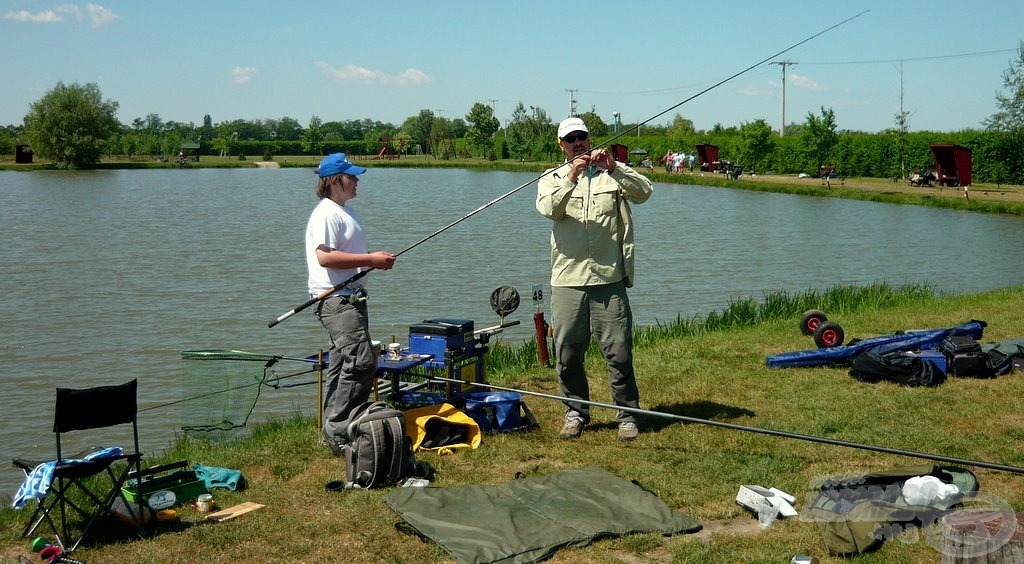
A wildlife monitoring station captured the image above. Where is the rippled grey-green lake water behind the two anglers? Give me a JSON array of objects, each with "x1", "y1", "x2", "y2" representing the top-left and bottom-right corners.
[{"x1": 0, "y1": 169, "x2": 1024, "y2": 495}]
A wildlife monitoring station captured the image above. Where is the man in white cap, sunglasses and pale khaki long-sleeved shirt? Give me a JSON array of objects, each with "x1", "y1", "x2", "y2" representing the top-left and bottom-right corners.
[{"x1": 537, "y1": 118, "x2": 653, "y2": 440}]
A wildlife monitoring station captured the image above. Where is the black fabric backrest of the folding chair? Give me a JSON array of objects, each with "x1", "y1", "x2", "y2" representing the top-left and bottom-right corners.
[{"x1": 53, "y1": 380, "x2": 138, "y2": 436}]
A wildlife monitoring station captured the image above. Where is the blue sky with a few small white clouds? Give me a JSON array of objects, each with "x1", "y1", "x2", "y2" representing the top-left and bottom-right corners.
[{"x1": 0, "y1": 0, "x2": 1024, "y2": 132}]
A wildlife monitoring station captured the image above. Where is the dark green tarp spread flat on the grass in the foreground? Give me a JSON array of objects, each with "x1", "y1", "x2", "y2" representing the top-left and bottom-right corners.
[{"x1": 384, "y1": 467, "x2": 700, "y2": 563}]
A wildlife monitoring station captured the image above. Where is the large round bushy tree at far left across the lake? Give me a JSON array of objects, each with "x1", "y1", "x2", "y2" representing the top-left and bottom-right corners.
[{"x1": 25, "y1": 82, "x2": 121, "y2": 168}]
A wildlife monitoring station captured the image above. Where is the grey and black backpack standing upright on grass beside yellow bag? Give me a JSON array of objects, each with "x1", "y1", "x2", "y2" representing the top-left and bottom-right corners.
[{"x1": 345, "y1": 401, "x2": 416, "y2": 489}]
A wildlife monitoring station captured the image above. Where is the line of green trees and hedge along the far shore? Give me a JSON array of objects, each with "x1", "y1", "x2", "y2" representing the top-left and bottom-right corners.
[{"x1": 6, "y1": 42, "x2": 1024, "y2": 184}]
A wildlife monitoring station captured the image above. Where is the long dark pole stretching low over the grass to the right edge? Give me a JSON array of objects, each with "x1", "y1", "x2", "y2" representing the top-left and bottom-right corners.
[{"x1": 430, "y1": 376, "x2": 1024, "y2": 474}]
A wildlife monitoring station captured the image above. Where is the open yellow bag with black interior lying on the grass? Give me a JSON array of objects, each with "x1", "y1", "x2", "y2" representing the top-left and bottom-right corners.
[{"x1": 406, "y1": 403, "x2": 480, "y2": 453}]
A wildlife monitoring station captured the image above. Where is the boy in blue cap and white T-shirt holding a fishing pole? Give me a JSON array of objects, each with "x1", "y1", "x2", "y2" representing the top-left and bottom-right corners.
[{"x1": 306, "y1": 153, "x2": 395, "y2": 455}]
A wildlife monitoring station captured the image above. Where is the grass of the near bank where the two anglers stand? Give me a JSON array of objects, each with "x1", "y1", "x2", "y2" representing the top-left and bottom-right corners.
[{"x1": 0, "y1": 286, "x2": 1024, "y2": 563}]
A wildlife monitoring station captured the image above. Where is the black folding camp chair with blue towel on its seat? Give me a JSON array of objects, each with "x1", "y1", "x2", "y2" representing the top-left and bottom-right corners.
[{"x1": 14, "y1": 380, "x2": 145, "y2": 553}]
